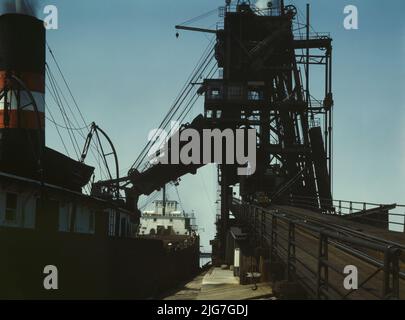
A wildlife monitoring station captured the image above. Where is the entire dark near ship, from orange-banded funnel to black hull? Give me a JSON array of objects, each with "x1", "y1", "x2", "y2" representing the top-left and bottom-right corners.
[{"x1": 0, "y1": 14, "x2": 199, "y2": 299}]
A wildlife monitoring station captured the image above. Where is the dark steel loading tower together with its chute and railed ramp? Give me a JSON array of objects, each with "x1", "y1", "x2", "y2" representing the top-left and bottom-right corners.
[{"x1": 91, "y1": 0, "x2": 405, "y2": 299}]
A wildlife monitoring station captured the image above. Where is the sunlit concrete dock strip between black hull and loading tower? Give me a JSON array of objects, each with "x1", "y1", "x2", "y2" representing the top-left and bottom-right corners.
[{"x1": 164, "y1": 268, "x2": 273, "y2": 300}]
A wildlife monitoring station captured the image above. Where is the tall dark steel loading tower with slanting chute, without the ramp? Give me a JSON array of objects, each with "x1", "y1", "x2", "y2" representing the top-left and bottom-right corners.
[{"x1": 94, "y1": 1, "x2": 333, "y2": 262}]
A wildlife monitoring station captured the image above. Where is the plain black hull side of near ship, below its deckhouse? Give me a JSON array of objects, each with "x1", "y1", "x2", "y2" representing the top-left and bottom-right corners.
[{"x1": 0, "y1": 225, "x2": 199, "y2": 299}]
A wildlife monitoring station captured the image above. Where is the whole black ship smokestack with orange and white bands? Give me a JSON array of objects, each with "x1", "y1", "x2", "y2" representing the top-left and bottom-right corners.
[{"x1": 0, "y1": 11, "x2": 46, "y2": 176}]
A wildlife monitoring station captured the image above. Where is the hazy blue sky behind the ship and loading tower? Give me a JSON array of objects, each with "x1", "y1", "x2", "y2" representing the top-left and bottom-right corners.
[{"x1": 21, "y1": 0, "x2": 405, "y2": 249}]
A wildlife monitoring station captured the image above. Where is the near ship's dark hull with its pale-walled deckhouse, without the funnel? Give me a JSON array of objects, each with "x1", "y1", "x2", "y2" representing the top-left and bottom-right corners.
[{"x1": 0, "y1": 174, "x2": 199, "y2": 299}]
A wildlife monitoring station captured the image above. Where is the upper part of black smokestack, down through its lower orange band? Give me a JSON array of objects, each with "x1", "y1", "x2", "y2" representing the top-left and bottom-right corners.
[{"x1": 0, "y1": 14, "x2": 45, "y2": 135}]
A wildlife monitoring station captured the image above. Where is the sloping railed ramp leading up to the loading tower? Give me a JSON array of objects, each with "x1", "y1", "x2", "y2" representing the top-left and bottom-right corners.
[{"x1": 231, "y1": 199, "x2": 405, "y2": 299}]
